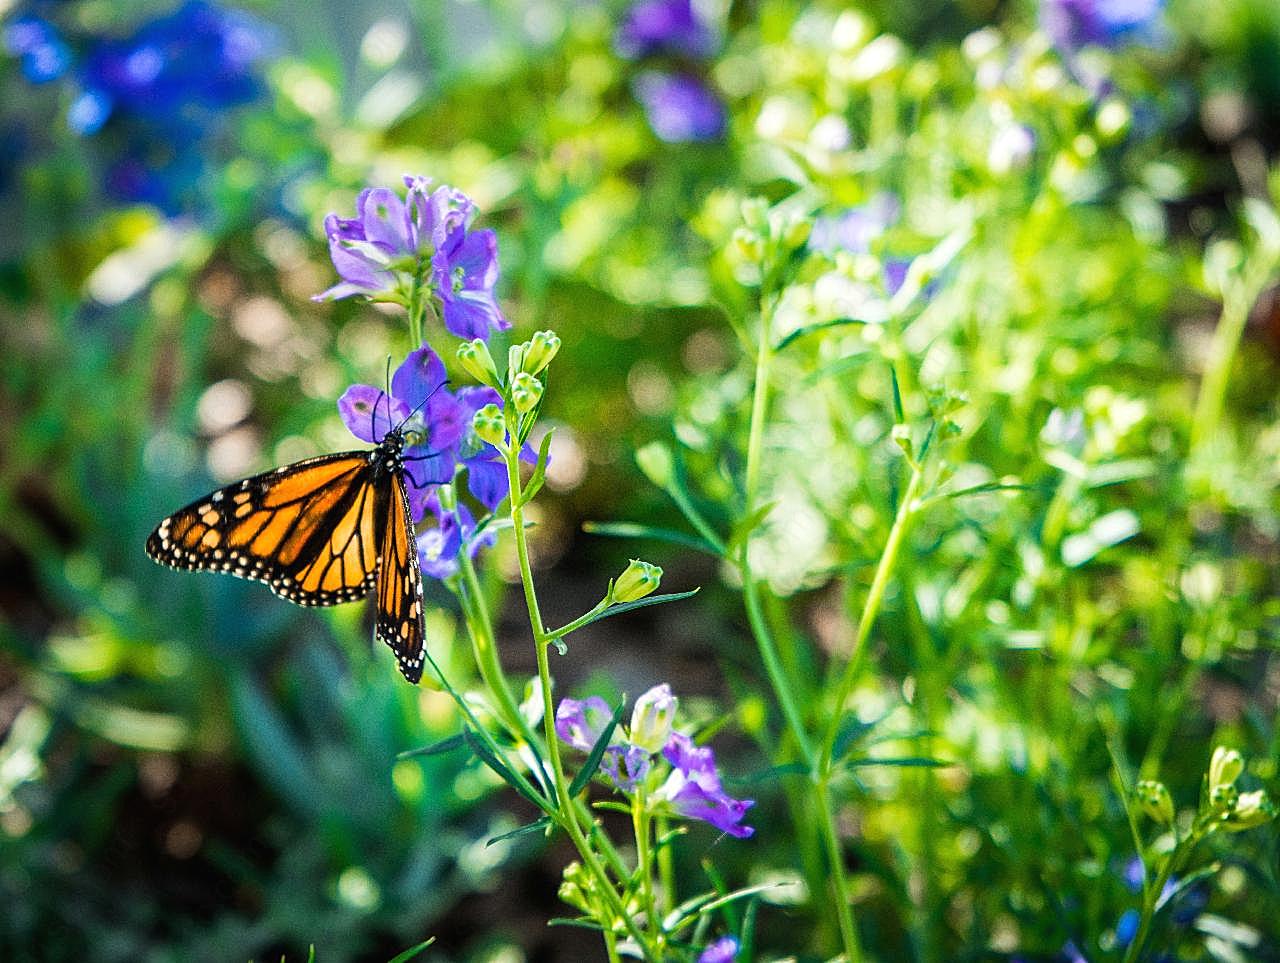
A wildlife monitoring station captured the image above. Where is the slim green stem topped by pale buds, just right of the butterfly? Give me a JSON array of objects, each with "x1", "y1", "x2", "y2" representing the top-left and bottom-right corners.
[{"x1": 504, "y1": 414, "x2": 659, "y2": 960}]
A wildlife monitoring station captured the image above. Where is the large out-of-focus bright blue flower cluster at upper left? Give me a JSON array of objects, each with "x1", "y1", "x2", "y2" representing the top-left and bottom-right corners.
[{"x1": 68, "y1": 0, "x2": 275, "y2": 135}]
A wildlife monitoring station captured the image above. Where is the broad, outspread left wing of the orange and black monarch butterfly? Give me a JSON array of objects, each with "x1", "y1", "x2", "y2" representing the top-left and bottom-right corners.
[{"x1": 147, "y1": 452, "x2": 381, "y2": 606}]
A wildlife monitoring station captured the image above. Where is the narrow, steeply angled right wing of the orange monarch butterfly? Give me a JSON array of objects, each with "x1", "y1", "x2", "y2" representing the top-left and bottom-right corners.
[{"x1": 374, "y1": 471, "x2": 426, "y2": 684}]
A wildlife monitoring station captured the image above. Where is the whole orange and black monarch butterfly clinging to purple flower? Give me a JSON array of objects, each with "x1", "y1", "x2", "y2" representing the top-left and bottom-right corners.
[{"x1": 147, "y1": 409, "x2": 426, "y2": 684}]
